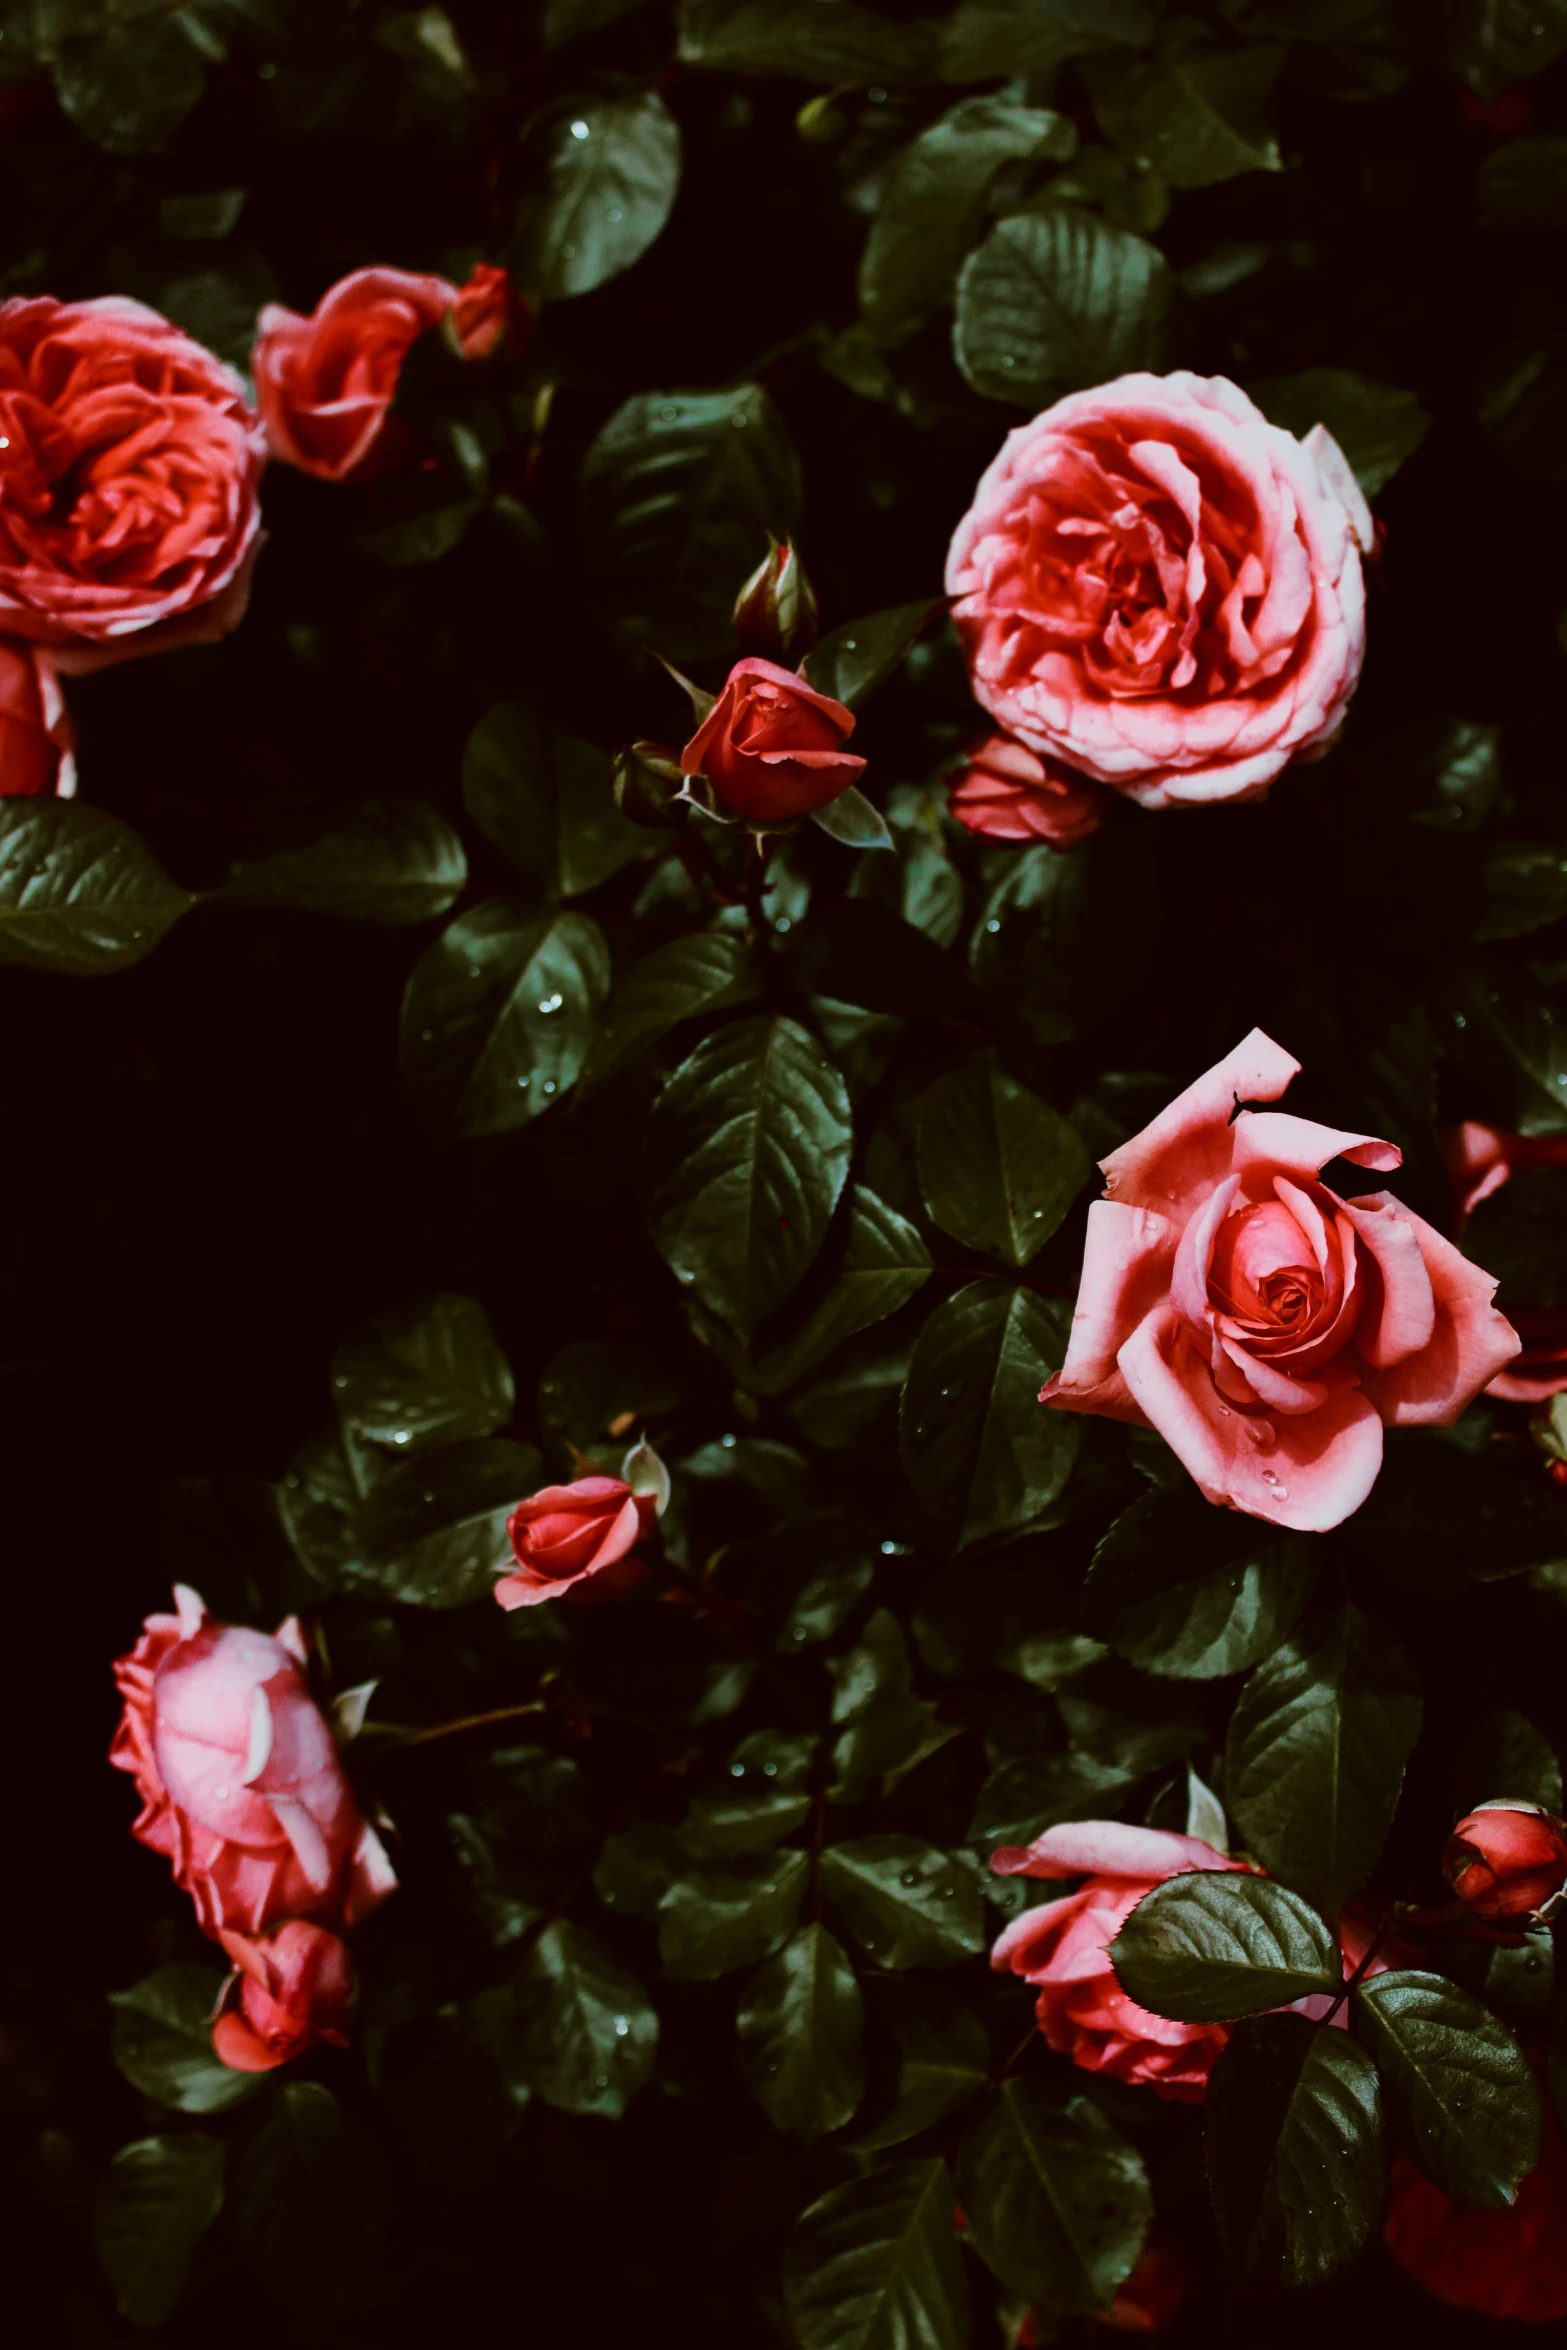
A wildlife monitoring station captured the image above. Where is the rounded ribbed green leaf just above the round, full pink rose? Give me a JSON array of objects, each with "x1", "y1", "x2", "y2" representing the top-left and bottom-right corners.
[{"x1": 954, "y1": 204, "x2": 1172, "y2": 409}]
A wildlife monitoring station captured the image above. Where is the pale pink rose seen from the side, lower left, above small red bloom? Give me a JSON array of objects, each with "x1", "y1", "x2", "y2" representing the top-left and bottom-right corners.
[{"x1": 108, "y1": 1584, "x2": 397, "y2": 1939}]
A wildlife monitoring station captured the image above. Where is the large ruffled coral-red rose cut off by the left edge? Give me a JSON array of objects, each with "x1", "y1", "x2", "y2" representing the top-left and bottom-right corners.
[{"x1": 0, "y1": 296, "x2": 265, "y2": 670}]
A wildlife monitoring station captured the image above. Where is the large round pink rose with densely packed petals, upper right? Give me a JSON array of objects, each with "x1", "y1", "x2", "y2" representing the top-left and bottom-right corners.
[{"x1": 947, "y1": 374, "x2": 1372, "y2": 808}]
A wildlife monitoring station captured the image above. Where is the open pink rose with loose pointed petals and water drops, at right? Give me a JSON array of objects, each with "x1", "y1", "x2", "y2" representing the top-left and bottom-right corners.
[{"x1": 1041, "y1": 1029, "x2": 1518, "y2": 1532}]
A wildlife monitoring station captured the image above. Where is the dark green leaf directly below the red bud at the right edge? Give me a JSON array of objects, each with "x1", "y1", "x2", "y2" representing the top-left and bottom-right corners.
[{"x1": 1349, "y1": 1972, "x2": 1541, "y2": 2209}]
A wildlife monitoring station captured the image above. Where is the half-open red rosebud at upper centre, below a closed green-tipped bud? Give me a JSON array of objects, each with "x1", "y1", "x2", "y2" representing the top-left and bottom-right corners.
[{"x1": 679, "y1": 660, "x2": 865, "y2": 825}]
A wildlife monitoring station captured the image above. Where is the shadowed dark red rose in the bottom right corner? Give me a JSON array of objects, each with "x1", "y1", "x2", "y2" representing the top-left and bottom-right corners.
[{"x1": 1384, "y1": 2103, "x2": 1567, "y2": 2327}]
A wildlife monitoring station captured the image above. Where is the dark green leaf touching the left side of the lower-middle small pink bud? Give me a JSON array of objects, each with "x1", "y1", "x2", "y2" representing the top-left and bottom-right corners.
[{"x1": 355, "y1": 1436, "x2": 540, "y2": 1607}]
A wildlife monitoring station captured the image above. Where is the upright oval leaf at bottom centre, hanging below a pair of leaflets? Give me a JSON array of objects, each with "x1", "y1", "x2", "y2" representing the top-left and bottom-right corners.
[{"x1": 738, "y1": 1925, "x2": 865, "y2": 2139}]
